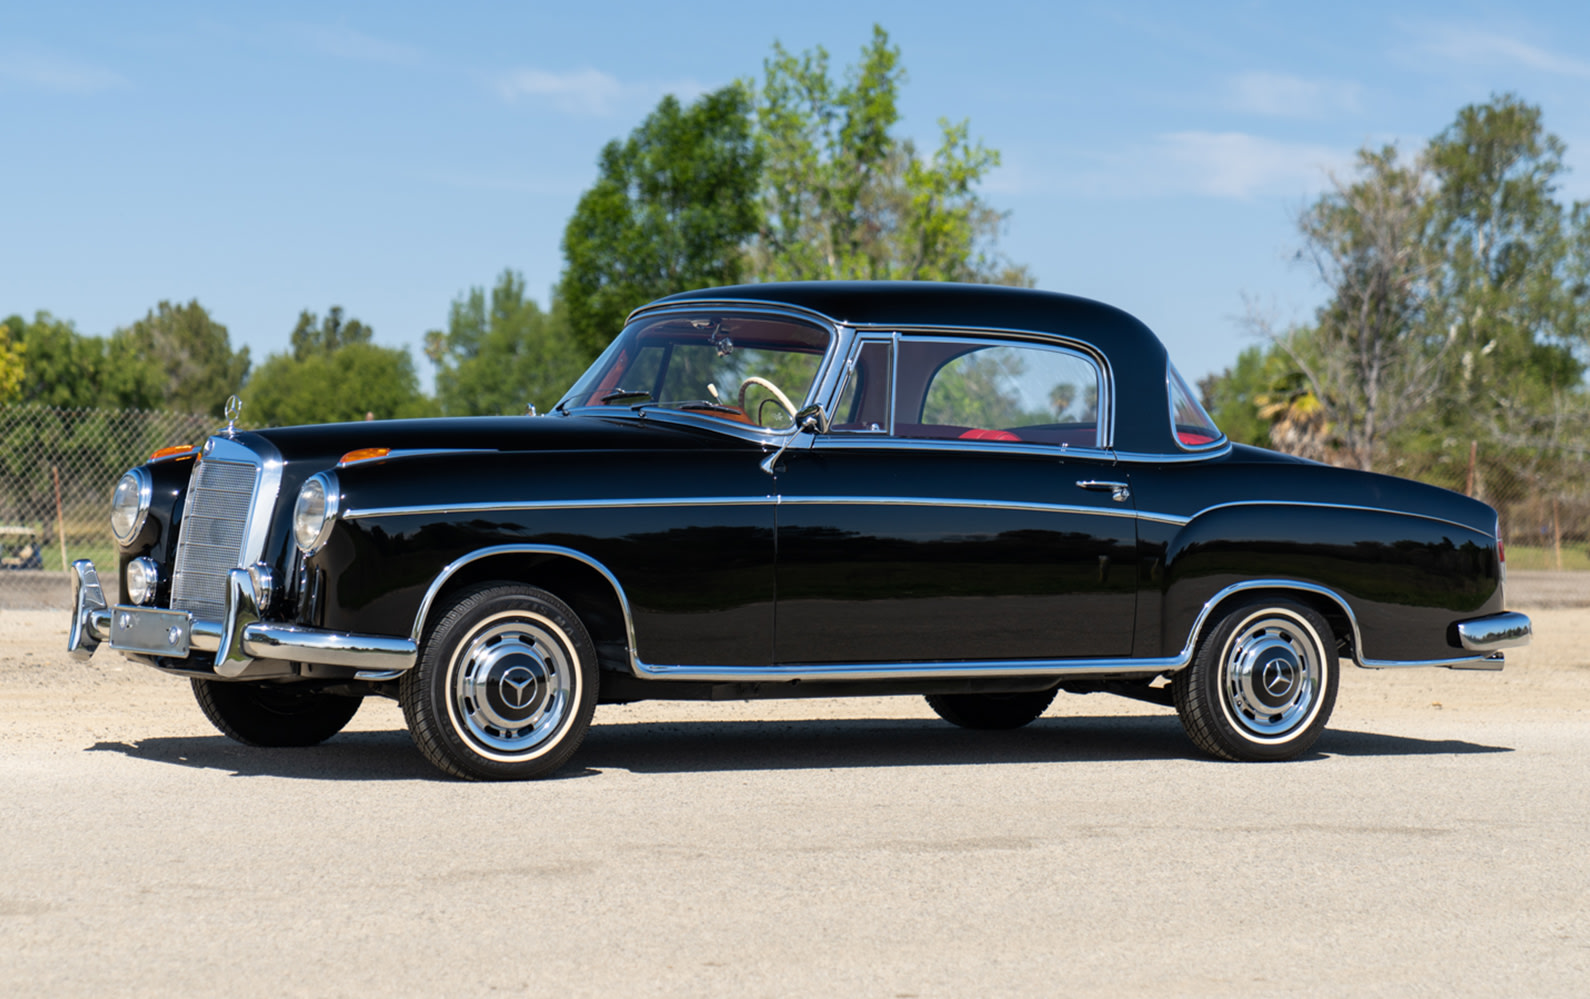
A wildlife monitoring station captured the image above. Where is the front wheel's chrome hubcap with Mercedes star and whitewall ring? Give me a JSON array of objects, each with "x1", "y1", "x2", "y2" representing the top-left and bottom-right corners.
[{"x1": 448, "y1": 611, "x2": 579, "y2": 760}]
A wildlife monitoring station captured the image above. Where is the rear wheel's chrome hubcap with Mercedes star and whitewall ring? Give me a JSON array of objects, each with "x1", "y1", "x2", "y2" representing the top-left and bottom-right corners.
[{"x1": 1221, "y1": 611, "x2": 1324, "y2": 738}]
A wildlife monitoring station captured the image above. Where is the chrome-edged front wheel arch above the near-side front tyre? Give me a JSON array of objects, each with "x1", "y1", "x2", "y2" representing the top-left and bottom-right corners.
[{"x1": 410, "y1": 544, "x2": 636, "y2": 674}]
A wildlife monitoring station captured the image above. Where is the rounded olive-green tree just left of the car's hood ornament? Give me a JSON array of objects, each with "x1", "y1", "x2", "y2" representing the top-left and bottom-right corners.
[{"x1": 107, "y1": 299, "x2": 248, "y2": 417}]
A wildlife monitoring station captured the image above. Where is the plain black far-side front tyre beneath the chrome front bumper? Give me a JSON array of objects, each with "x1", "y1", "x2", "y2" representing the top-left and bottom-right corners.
[{"x1": 192, "y1": 678, "x2": 364, "y2": 746}]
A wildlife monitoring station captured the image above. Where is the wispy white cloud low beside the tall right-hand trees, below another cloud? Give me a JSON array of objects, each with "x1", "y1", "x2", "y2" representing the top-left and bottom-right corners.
[{"x1": 1151, "y1": 132, "x2": 1353, "y2": 199}]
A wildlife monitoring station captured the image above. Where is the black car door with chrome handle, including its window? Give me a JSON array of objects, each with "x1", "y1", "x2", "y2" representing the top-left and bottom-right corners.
[{"x1": 774, "y1": 336, "x2": 1137, "y2": 663}]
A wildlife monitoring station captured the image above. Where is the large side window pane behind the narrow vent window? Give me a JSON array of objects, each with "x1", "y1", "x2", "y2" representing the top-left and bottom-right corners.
[{"x1": 894, "y1": 339, "x2": 1099, "y2": 447}]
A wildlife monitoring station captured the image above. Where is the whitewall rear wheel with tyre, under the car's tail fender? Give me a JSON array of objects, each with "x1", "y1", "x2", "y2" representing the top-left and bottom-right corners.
[{"x1": 1170, "y1": 600, "x2": 1339, "y2": 760}]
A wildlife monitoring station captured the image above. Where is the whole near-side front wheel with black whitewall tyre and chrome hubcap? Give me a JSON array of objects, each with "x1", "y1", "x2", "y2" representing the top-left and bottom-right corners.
[{"x1": 399, "y1": 584, "x2": 596, "y2": 781}]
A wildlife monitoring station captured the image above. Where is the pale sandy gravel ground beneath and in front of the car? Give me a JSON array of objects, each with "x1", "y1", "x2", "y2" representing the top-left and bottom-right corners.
[{"x1": 0, "y1": 600, "x2": 1590, "y2": 997}]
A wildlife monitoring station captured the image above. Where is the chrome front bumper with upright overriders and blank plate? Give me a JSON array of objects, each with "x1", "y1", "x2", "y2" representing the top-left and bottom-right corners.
[{"x1": 67, "y1": 558, "x2": 418, "y2": 681}]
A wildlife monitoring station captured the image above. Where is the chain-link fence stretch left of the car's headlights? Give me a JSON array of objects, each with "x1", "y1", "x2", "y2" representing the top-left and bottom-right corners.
[{"x1": 0, "y1": 406, "x2": 216, "y2": 606}]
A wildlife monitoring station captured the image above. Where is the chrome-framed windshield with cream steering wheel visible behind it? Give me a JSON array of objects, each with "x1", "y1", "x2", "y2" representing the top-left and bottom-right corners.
[{"x1": 558, "y1": 313, "x2": 830, "y2": 430}]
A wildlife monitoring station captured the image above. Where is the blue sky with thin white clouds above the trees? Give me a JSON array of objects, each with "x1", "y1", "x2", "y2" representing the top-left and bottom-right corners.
[{"x1": 0, "y1": 0, "x2": 1590, "y2": 392}]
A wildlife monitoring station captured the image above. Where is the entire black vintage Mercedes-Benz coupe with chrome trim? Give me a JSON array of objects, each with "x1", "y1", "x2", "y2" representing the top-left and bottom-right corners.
[{"x1": 70, "y1": 283, "x2": 1530, "y2": 779}]
